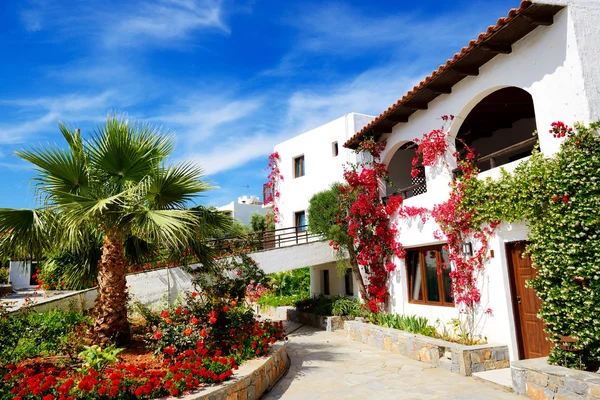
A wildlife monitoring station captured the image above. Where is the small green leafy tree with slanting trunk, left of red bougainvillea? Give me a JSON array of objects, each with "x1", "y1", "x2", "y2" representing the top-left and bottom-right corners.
[{"x1": 308, "y1": 183, "x2": 368, "y2": 299}]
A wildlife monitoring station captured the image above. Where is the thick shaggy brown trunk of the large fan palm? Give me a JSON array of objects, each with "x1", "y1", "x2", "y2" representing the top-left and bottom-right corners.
[{"x1": 93, "y1": 231, "x2": 131, "y2": 344}]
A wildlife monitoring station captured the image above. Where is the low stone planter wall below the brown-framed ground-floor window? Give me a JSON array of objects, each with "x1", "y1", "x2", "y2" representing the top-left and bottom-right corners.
[{"x1": 344, "y1": 318, "x2": 509, "y2": 376}]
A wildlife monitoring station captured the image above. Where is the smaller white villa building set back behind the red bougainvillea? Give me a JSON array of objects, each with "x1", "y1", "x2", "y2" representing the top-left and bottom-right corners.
[{"x1": 265, "y1": 113, "x2": 374, "y2": 296}]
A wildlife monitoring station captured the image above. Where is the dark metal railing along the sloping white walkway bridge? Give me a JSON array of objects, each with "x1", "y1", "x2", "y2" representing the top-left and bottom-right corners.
[{"x1": 207, "y1": 225, "x2": 322, "y2": 252}]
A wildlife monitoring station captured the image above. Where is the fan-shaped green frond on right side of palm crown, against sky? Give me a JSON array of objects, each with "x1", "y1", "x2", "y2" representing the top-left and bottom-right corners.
[{"x1": 146, "y1": 162, "x2": 213, "y2": 209}]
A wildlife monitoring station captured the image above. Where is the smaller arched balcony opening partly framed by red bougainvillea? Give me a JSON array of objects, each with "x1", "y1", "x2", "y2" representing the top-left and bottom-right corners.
[{"x1": 387, "y1": 142, "x2": 427, "y2": 199}]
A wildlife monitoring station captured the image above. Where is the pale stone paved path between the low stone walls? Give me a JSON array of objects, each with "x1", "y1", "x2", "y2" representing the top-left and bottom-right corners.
[{"x1": 263, "y1": 323, "x2": 526, "y2": 400}]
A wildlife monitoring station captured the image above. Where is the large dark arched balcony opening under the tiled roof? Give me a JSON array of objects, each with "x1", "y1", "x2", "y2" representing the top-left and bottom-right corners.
[{"x1": 456, "y1": 87, "x2": 537, "y2": 171}]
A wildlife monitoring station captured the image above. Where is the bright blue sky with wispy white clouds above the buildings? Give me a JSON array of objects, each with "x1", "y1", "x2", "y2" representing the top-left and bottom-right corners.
[{"x1": 0, "y1": 0, "x2": 518, "y2": 207}]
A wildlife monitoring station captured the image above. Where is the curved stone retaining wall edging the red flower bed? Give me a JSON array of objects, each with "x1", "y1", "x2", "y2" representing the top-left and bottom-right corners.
[{"x1": 170, "y1": 342, "x2": 290, "y2": 400}]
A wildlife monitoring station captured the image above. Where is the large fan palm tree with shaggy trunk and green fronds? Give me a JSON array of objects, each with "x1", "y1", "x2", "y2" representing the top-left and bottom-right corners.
[{"x1": 0, "y1": 116, "x2": 230, "y2": 343}]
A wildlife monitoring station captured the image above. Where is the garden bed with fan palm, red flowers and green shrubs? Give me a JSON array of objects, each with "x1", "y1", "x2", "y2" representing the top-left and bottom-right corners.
[{"x1": 0, "y1": 116, "x2": 284, "y2": 400}]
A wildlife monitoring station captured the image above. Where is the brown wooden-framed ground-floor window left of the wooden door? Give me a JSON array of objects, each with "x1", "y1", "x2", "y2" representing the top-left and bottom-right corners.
[{"x1": 405, "y1": 246, "x2": 454, "y2": 307}]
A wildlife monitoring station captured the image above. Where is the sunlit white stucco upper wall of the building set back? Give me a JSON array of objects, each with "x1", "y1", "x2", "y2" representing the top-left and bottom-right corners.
[{"x1": 275, "y1": 113, "x2": 373, "y2": 228}]
